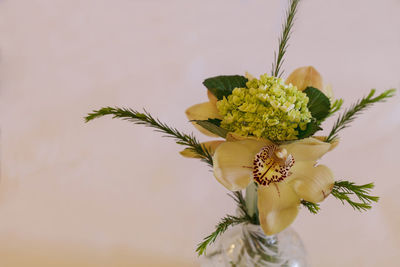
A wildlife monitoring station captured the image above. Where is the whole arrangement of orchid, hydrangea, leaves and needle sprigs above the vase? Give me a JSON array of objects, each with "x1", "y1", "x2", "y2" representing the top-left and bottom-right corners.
[{"x1": 85, "y1": 0, "x2": 395, "y2": 260}]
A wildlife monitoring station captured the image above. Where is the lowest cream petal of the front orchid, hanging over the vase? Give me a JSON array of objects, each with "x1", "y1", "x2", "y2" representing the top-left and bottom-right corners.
[{"x1": 258, "y1": 181, "x2": 300, "y2": 235}]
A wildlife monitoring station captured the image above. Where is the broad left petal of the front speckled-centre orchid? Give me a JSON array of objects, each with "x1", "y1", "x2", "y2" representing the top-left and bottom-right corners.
[{"x1": 213, "y1": 140, "x2": 265, "y2": 191}]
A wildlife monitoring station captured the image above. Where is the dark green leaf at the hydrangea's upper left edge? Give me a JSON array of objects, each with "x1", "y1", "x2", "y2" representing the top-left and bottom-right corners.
[{"x1": 203, "y1": 75, "x2": 248, "y2": 100}]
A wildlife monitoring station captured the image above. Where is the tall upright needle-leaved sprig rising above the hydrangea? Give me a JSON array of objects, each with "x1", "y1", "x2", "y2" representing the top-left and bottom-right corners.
[{"x1": 272, "y1": 0, "x2": 300, "y2": 77}]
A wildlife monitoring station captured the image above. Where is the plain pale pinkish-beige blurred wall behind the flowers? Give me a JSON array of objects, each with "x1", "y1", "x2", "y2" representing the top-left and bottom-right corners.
[{"x1": 0, "y1": 0, "x2": 400, "y2": 267}]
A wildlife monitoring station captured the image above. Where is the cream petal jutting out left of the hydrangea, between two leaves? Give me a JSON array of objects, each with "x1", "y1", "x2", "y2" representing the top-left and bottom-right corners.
[{"x1": 186, "y1": 102, "x2": 221, "y2": 137}]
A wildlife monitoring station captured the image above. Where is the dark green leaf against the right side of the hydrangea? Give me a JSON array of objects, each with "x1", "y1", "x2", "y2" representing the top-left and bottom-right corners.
[{"x1": 304, "y1": 87, "x2": 331, "y2": 121}]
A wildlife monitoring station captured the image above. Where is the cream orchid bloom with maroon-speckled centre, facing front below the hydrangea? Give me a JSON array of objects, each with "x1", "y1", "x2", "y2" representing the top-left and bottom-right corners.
[{"x1": 213, "y1": 137, "x2": 336, "y2": 235}]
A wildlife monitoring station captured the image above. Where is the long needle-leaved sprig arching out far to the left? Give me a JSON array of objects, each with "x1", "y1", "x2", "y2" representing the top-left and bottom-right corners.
[{"x1": 85, "y1": 107, "x2": 213, "y2": 166}]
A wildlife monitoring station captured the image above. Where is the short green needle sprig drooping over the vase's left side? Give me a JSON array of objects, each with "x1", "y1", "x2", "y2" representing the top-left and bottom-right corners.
[{"x1": 196, "y1": 215, "x2": 248, "y2": 256}]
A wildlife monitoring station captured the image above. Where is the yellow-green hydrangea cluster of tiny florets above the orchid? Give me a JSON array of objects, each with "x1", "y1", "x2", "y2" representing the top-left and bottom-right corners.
[{"x1": 217, "y1": 74, "x2": 311, "y2": 141}]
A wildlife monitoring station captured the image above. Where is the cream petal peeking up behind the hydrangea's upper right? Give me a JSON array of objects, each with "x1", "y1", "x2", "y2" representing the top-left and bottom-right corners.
[{"x1": 286, "y1": 66, "x2": 322, "y2": 91}]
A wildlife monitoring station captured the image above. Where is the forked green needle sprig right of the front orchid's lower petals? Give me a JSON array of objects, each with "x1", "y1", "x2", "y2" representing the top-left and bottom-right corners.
[{"x1": 331, "y1": 181, "x2": 379, "y2": 211}]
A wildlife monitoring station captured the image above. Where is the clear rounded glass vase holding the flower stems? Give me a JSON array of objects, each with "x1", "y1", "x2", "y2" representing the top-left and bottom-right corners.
[{"x1": 200, "y1": 224, "x2": 307, "y2": 267}]
